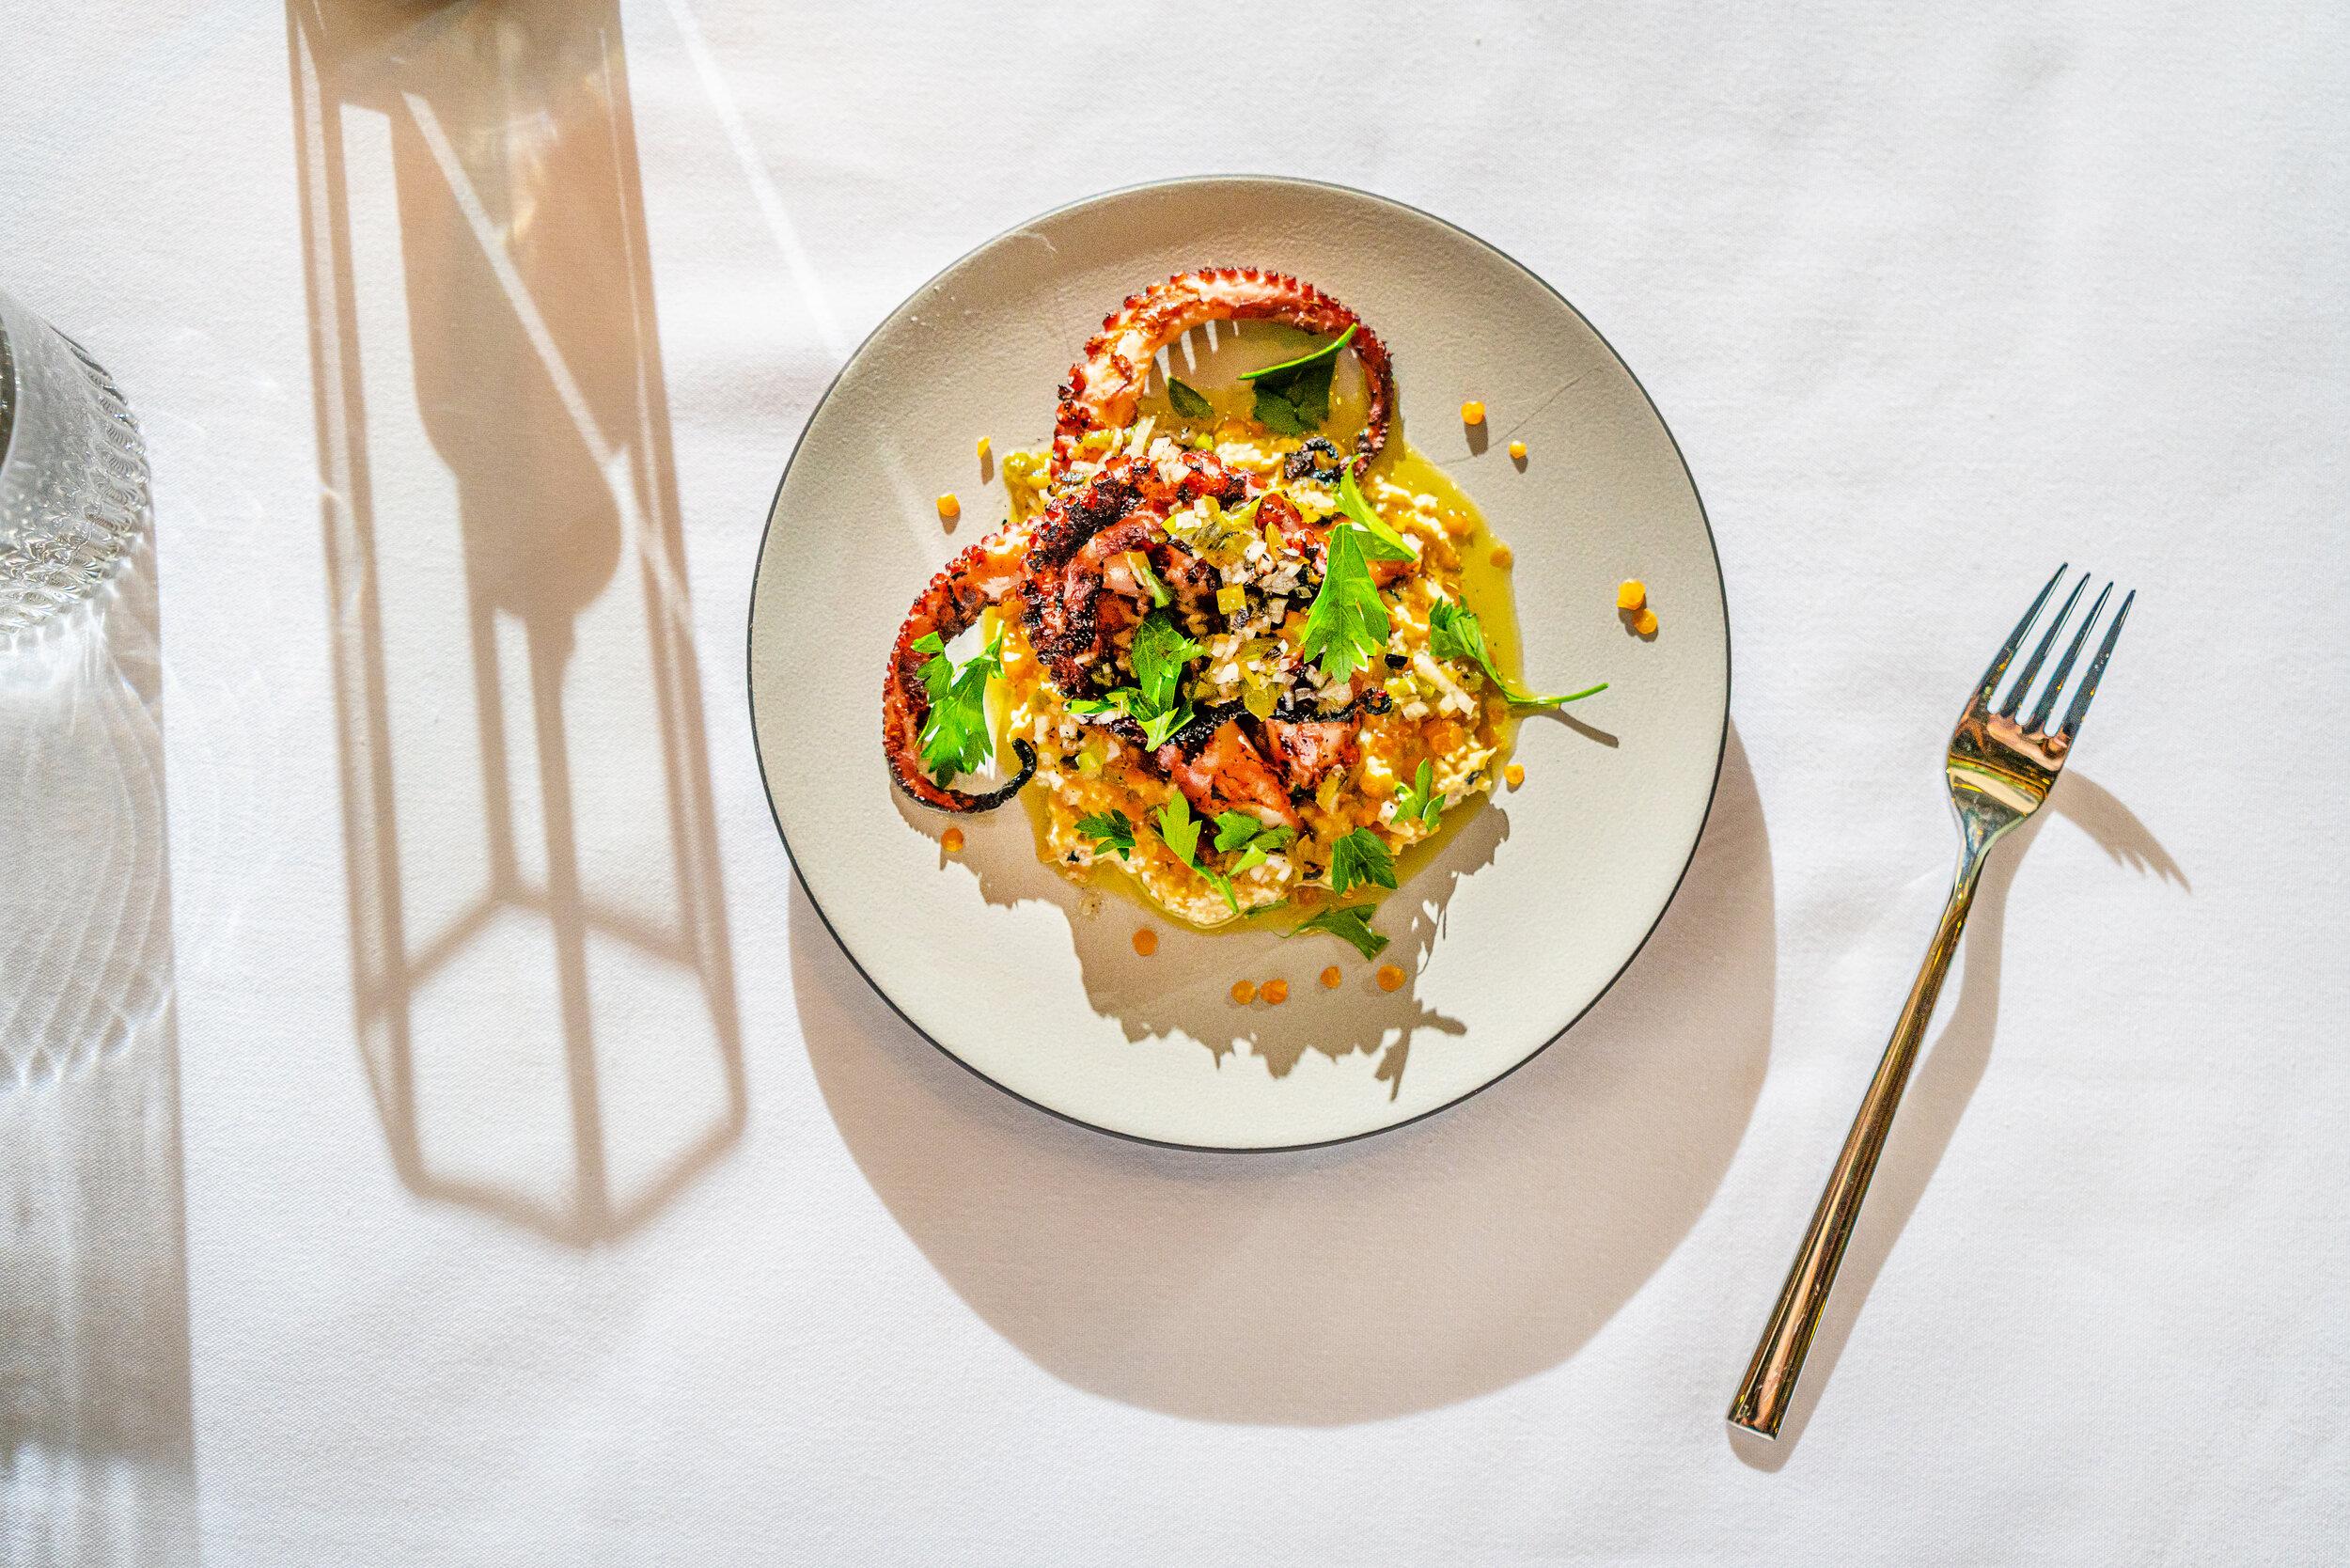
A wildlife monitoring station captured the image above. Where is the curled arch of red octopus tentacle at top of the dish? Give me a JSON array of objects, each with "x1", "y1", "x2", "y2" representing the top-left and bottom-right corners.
[{"x1": 1051, "y1": 266, "x2": 1396, "y2": 479}]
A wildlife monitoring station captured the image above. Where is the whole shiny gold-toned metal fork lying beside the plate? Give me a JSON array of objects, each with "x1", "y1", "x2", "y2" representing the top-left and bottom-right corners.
[{"x1": 1730, "y1": 567, "x2": 2138, "y2": 1438}]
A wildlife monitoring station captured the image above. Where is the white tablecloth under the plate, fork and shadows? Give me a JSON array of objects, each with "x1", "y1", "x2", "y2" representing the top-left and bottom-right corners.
[{"x1": 0, "y1": 0, "x2": 2350, "y2": 1568}]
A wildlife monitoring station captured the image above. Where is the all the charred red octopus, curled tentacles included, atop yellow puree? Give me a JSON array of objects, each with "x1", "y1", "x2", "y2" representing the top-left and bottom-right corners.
[{"x1": 882, "y1": 268, "x2": 1396, "y2": 825}]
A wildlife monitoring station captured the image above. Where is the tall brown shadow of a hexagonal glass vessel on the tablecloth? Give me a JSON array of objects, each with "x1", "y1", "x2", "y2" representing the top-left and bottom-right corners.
[{"x1": 287, "y1": 0, "x2": 747, "y2": 1246}]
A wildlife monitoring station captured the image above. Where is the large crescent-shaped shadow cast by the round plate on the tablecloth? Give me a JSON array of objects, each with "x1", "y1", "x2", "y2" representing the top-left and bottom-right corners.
[{"x1": 792, "y1": 731, "x2": 1777, "y2": 1427}]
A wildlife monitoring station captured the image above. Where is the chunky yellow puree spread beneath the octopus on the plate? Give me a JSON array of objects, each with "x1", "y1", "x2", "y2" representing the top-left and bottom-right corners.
[{"x1": 990, "y1": 381, "x2": 1516, "y2": 929}]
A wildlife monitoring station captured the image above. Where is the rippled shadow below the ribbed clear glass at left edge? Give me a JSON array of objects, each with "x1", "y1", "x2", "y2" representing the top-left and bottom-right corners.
[{"x1": 0, "y1": 543, "x2": 197, "y2": 1563}]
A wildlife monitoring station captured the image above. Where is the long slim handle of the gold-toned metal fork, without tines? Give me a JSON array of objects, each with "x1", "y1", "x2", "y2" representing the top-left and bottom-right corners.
[{"x1": 1730, "y1": 835, "x2": 1991, "y2": 1438}]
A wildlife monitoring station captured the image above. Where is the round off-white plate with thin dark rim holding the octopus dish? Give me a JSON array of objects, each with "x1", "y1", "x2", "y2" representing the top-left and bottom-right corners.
[{"x1": 750, "y1": 179, "x2": 1730, "y2": 1150}]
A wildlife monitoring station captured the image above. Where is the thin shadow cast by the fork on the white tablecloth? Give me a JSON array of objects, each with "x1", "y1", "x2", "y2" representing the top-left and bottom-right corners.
[{"x1": 1725, "y1": 774, "x2": 2190, "y2": 1471}]
